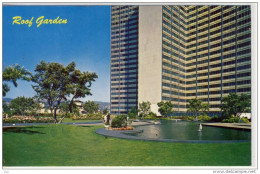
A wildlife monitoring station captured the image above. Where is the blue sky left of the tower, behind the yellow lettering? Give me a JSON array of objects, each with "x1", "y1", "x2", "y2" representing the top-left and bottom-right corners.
[{"x1": 2, "y1": 6, "x2": 110, "y2": 102}]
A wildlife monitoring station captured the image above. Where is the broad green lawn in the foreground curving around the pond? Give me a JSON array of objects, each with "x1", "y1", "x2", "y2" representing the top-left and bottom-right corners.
[{"x1": 3, "y1": 125, "x2": 251, "y2": 166}]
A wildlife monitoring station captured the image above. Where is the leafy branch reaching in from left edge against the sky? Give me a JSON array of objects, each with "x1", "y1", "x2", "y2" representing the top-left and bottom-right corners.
[{"x1": 3, "y1": 64, "x2": 31, "y2": 96}]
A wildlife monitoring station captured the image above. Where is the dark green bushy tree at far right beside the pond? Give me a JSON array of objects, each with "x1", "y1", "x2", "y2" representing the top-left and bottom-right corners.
[{"x1": 220, "y1": 93, "x2": 251, "y2": 118}]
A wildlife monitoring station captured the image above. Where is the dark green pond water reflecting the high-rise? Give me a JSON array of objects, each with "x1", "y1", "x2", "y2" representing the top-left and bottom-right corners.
[{"x1": 127, "y1": 120, "x2": 251, "y2": 140}]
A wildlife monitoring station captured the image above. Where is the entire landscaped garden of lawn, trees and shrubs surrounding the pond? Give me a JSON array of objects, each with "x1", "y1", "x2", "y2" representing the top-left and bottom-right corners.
[{"x1": 3, "y1": 61, "x2": 251, "y2": 166}]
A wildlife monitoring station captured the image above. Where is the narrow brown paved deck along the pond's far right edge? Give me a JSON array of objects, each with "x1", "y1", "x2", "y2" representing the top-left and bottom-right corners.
[{"x1": 201, "y1": 123, "x2": 251, "y2": 130}]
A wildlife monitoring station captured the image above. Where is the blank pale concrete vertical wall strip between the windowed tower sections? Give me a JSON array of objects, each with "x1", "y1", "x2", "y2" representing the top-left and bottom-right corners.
[{"x1": 138, "y1": 6, "x2": 162, "y2": 115}]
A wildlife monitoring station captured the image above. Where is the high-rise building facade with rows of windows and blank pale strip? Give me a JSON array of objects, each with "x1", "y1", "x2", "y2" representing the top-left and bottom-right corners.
[{"x1": 111, "y1": 5, "x2": 251, "y2": 115}]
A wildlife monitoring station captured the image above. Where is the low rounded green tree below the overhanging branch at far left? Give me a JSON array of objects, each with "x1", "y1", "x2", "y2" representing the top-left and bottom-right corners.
[{"x1": 9, "y1": 97, "x2": 40, "y2": 115}]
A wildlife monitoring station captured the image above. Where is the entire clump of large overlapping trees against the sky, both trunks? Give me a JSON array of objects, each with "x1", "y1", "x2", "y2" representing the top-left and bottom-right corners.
[{"x1": 32, "y1": 61, "x2": 97, "y2": 123}]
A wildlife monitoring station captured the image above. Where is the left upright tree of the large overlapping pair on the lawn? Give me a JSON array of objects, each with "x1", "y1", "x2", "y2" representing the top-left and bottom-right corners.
[{"x1": 32, "y1": 61, "x2": 72, "y2": 123}]
